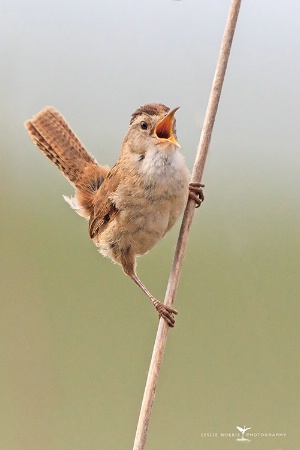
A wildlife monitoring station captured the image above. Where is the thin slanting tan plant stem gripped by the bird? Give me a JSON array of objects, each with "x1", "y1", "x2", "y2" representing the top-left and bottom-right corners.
[{"x1": 133, "y1": 0, "x2": 241, "y2": 450}]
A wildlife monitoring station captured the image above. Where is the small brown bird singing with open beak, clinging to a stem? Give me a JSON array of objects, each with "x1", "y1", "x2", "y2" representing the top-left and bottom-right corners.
[{"x1": 25, "y1": 103, "x2": 204, "y2": 327}]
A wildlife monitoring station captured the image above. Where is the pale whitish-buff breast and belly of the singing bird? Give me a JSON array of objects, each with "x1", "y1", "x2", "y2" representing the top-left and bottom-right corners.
[{"x1": 97, "y1": 145, "x2": 190, "y2": 262}]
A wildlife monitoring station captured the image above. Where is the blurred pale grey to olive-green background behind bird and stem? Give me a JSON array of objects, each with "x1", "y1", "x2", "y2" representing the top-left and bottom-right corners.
[{"x1": 0, "y1": 0, "x2": 300, "y2": 450}]
